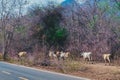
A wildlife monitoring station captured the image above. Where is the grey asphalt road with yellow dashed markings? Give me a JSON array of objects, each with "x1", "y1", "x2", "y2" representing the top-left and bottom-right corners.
[{"x1": 0, "y1": 62, "x2": 90, "y2": 80}]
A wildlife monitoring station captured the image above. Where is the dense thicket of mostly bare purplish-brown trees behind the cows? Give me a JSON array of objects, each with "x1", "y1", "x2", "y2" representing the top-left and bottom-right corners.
[{"x1": 0, "y1": 0, "x2": 120, "y2": 63}]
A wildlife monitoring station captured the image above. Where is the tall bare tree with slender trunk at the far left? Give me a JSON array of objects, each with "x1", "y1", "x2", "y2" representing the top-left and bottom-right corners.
[{"x1": 0, "y1": 0, "x2": 26, "y2": 60}]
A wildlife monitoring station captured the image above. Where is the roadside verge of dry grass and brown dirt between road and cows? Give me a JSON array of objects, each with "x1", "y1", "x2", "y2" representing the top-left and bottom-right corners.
[{"x1": 2, "y1": 57, "x2": 120, "y2": 80}]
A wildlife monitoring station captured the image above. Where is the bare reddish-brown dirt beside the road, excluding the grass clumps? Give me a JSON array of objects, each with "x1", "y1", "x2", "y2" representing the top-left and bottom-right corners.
[{"x1": 34, "y1": 63, "x2": 120, "y2": 80}]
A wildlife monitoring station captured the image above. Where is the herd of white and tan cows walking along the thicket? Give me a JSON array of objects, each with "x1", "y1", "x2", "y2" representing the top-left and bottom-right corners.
[{"x1": 18, "y1": 51, "x2": 111, "y2": 63}]
